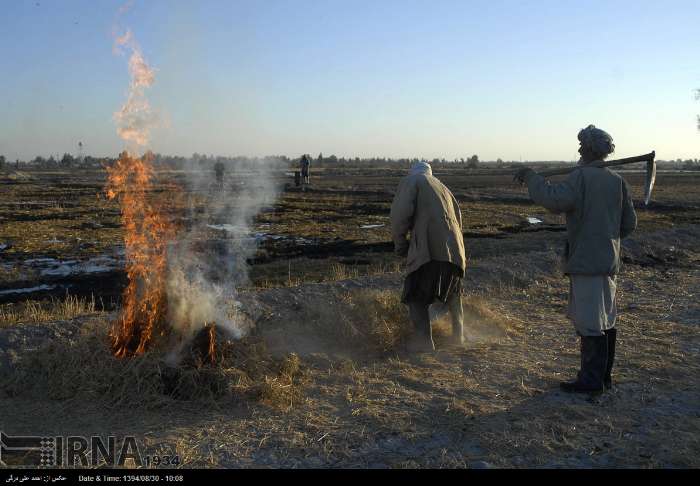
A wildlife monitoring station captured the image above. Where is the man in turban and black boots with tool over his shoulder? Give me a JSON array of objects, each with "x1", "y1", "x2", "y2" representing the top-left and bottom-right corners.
[{"x1": 515, "y1": 125, "x2": 637, "y2": 392}]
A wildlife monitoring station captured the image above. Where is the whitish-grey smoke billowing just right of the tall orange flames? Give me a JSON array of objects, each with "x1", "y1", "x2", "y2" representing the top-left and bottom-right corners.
[{"x1": 168, "y1": 159, "x2": 279, "y2": 356}]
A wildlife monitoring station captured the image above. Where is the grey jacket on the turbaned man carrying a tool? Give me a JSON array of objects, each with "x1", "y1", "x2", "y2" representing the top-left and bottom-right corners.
[{"x1": 526, "y1": 165, "x2": 637, "y2": 275}]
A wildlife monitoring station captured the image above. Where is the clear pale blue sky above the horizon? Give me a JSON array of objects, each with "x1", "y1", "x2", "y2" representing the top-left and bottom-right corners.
[{"x1": 0, "y1": 0, "x2": 700, "y2": 161}]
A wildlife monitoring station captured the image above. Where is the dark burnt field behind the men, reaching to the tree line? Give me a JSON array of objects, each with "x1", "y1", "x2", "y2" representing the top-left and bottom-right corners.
[{"x1": 0, "y1": 168, "x2": 700, "y2": 302}]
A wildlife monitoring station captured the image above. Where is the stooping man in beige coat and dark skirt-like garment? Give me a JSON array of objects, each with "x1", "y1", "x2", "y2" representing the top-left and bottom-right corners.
[{"x1": 391, "y1": 162, "x2": 466, "y2": 352}]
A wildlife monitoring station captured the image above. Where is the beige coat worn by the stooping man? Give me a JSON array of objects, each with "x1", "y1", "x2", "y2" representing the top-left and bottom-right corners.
[{"x1": 391, "y1": 173, "x2": 466, "y2": 273}]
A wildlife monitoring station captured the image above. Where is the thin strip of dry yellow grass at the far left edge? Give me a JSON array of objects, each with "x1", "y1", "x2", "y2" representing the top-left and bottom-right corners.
[{"x1": 0, "y1": 295, "x2": 101, "y2": 327}]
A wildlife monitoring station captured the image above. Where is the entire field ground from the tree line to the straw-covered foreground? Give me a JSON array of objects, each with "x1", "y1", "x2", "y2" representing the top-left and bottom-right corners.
[{"x1": 0, "y1": 169, "x2": 700, "y2": 468}]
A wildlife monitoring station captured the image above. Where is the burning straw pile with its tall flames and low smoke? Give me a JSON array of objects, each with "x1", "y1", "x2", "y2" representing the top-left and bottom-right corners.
[{"x1": 0, "y1": 23, "x2": 300, "y2": 407}]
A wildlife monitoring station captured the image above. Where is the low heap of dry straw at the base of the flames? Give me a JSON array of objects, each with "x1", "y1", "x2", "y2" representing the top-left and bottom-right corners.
[{"x1": 0, "y1": 321, "x2": 303, "y2": 409}]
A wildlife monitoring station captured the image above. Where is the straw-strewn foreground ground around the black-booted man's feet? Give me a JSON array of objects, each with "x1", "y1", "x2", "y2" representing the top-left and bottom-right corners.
[{"x1": 0, "y1": 269, "x2": 700, "y2": 467}]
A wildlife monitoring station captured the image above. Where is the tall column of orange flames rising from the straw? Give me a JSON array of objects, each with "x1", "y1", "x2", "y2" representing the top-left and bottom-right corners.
[{"x1": 105, "y1": 21, "x2": 216, "y2": 363}]
